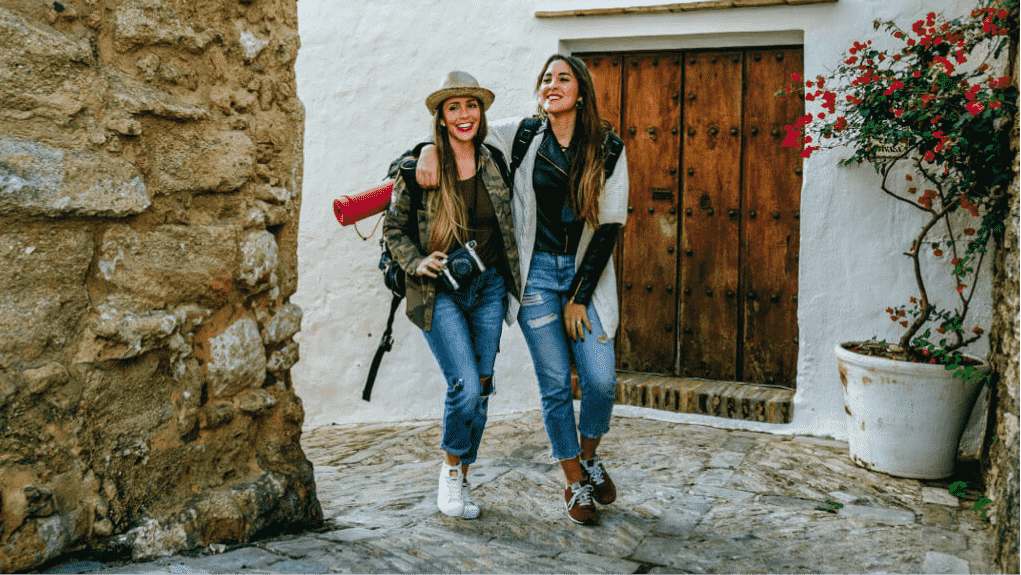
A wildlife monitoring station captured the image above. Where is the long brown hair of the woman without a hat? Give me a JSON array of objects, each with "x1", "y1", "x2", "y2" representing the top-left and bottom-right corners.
[{"x1": 535, "y1": 54, "x2": 610, "y2": 228}]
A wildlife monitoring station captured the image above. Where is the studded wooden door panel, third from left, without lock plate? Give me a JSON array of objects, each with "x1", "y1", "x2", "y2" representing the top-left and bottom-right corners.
[{"x1": 680, "y1": 52, "x2": 742, "y2": 381}]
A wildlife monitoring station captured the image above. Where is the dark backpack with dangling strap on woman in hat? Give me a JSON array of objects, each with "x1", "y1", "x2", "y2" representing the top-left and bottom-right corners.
[{"x1": 361, "y1": 144, "x2": 510, "y2": 401}]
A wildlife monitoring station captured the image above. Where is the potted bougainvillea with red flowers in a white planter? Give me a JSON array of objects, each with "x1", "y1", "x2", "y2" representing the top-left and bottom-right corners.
[{"x1": 779, "y1": 0, "x2": 1018, "y2": 479}]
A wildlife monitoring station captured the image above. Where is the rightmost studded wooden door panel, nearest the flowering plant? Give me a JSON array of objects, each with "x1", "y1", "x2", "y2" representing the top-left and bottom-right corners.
[{"x1": 741, "y1": 48, "x2": 805, "y2": 387}]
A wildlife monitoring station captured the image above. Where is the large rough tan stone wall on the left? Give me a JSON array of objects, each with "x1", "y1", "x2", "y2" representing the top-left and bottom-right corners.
[{"x1": 0, "y1": 0, "x2": 322, "y2": 573}]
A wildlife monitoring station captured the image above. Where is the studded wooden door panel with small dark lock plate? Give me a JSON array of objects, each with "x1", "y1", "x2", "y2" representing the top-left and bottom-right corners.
[{"x1": 618, "y1": 54, "x2": 681, "y2": 373}]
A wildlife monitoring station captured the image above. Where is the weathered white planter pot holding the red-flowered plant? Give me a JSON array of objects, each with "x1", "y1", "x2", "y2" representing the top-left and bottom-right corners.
[{"x1": 835, "y1": 345, "x2": 989, "y2": 479}]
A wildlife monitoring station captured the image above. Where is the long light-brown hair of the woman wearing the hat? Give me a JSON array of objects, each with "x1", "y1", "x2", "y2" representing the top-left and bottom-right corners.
[{"x1": 428, "y1": 96, "x2": 488, "y2": 253}]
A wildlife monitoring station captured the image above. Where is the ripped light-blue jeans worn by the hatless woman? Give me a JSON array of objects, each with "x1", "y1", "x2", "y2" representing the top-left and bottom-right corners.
[{"x1": 518, "y1": 251, "x2": 617, "y2": 460}]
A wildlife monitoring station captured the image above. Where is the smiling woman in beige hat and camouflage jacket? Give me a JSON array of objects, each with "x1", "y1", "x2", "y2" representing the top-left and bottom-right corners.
[{"x1": 383, "y1": 71, "x2": 521, "y2": 519}]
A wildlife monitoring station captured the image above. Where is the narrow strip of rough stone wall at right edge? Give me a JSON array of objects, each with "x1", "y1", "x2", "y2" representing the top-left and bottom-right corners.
[{"x1": 982, "y1": 28, "x2": 1021, "y2": 573}]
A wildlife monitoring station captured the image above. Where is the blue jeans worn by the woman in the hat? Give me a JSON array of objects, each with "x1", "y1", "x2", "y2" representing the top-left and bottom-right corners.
[{"x1": 422, "y1": 268, "x2": 506, "y2": 465}]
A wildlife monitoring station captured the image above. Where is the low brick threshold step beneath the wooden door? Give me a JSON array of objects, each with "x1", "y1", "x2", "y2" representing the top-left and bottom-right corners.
[{"x1": 571, "y1": 369, "x2": 794, "y2": 424}]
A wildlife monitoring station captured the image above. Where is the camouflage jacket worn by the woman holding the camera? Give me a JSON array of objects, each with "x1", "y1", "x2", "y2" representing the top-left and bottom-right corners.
[{"x1": 383, "y1": 146, "x2": 521, "y2": 331}]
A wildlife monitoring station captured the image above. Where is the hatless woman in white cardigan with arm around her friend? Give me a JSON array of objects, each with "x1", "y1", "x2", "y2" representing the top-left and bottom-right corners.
[{"x1": 418, "y1": 54, "x2": 628, "y2": 525}]
